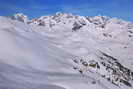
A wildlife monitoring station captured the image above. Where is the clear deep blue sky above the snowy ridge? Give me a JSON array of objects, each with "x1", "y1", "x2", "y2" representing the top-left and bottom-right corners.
[{"x1": 0, "y1": 0, "x2": 133, "y2": 22}]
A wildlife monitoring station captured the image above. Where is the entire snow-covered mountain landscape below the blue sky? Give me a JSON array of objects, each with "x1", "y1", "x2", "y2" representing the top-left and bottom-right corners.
[{"x1": 0, "y1": 13, "x2": 133, "y2": 89}]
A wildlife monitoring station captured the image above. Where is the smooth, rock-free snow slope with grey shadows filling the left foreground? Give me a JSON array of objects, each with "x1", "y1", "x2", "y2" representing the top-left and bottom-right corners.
[{"x1": 0, "y1": 17, "x2": 109, "y2": 89}]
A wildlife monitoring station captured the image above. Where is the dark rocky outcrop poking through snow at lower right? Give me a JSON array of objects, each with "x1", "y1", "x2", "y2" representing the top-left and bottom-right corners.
[{"x1": 73, "y1": 52, "x2": 133, "y2": 87}]
